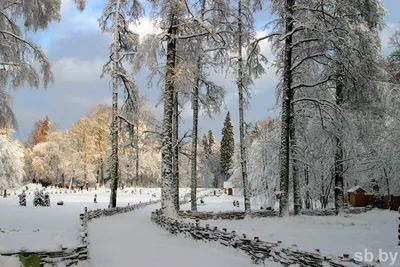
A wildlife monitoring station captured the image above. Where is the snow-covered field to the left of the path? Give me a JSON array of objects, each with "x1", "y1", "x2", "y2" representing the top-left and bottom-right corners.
[{"x1": 0, "y1": 184, "x2": 195, "y2": 252}]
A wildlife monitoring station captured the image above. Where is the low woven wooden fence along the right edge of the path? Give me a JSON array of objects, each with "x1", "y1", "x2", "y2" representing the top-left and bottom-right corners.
[{"x1": 151, "y1": 210, "x2": 379, "y2": 267}]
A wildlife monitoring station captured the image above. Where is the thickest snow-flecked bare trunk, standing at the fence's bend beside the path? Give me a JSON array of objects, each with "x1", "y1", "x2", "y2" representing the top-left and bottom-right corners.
[{"x1": 161, "y1": 11, "x2": 177, "y2": 216}]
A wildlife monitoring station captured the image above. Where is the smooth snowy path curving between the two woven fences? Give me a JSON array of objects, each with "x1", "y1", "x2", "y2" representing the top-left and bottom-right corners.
[{"x1": 88, "y1": 206, "x2": 268, "y2": 267}]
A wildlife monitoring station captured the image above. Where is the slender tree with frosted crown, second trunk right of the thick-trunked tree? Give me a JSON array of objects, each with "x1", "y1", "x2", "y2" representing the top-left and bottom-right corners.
[{"x1": 184, "y1": 0, "x2": 229, "y2": 211}]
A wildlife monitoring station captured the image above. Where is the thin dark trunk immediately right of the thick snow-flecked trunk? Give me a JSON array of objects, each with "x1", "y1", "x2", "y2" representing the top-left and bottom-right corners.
[{"x1": 172, "y1": 92, "x2": 179, "y2": 210}]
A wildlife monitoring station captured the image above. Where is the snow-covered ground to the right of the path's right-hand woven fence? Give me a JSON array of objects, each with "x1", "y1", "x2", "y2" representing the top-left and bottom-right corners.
[{"x1": 182, "y1": 195, "x2": 400, "y2": 266}]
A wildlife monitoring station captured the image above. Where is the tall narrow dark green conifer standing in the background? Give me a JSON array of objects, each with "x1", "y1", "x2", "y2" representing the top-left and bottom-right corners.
[{"x1": 221, "y1": 112, "x2": 235, "y2": 184}]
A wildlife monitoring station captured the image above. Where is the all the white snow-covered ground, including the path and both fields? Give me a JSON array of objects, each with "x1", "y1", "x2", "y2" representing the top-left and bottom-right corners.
[{"x1": 0, "y1": 188, "x2": 400, "y2": 267}]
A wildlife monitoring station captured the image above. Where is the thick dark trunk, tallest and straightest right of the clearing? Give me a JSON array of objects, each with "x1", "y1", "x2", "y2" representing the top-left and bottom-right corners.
[{"x1": 279, "y1": 0, "x2": 295, "y2": 216}]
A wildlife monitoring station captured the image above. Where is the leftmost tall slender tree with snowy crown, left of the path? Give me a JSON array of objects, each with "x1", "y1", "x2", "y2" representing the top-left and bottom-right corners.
[{"x1": 99, "y1": 0, "x2": 143, "y2": 207}]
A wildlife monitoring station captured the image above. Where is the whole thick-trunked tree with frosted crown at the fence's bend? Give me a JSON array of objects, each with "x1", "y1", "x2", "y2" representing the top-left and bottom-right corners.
[{"x1": 135, "y1": 0, "x2": 230, "y2": 216}]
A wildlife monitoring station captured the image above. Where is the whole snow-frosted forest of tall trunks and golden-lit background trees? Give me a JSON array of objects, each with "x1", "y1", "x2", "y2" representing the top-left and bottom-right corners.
[{"x1": 0, "y1": 0, "x2": 400, "y2": 216}]
